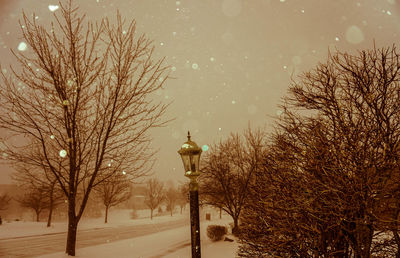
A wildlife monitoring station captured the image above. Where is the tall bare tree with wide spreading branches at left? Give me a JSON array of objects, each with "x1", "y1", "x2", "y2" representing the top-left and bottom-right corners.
[{"x1": 0, "y1": 0, "x2": 168, "y2": 256}]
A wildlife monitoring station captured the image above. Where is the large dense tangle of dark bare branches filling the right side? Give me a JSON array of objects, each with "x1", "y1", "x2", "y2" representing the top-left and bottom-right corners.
[{"x1": 240, "y1": 46, "x2": 400, "y2": 257}]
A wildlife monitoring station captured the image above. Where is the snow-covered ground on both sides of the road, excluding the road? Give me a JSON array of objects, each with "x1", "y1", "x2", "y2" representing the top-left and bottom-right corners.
[{"x1": 0, "y1": 210, "x2": 237, "y2": 258}]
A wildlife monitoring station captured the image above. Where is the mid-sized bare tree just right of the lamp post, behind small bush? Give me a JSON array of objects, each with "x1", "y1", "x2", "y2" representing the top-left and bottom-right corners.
[{"x1": 199, "y1": 128, "x2": 265, "y2": 234}]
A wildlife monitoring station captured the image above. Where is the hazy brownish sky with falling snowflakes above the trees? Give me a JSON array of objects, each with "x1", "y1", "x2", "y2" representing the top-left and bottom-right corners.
[{"x1": 0, "y1": 0, "x2": 400, "y2": 183}]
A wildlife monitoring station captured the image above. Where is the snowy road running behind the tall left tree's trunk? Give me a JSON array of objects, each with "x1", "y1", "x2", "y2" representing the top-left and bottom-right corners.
[{"x1": 0, "y1": 218, "x2": 188, "y2": 258}]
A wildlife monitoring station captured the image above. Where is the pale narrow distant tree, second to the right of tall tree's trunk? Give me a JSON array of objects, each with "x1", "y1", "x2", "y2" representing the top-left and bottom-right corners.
[{"x1": 144, "y1": 178, "x2": 164, "y2": 219}]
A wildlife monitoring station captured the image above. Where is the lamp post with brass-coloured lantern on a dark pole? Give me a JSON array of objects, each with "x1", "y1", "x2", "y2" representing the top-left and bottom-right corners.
[{"x1": 178, "y1": 132, "x2": 201, "y2": 258}]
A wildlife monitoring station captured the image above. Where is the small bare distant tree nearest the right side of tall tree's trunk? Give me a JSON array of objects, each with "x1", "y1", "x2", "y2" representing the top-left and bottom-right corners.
[{"x1": 94, "y1": 171, "x2": 132, "y2": 223}]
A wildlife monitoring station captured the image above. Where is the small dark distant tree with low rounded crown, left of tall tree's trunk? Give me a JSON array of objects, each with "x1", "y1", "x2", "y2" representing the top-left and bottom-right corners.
[{"x1": 17, "y1": 188, "x2": 49, "y2": 222}]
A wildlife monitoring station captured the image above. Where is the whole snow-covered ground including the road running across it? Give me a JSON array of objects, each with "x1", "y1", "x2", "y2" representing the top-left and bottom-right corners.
[{"x1": 0, "y1": 211, "x2": 237, "y2": 258}]
